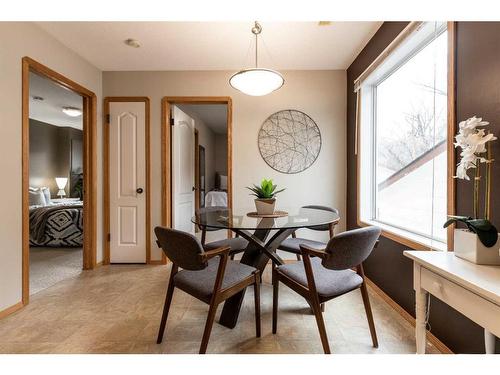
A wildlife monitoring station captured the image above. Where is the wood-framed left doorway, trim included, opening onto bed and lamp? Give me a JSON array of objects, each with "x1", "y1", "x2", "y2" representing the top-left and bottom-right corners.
[{"x1": 22, "y1": 57, "x2": 97, "y2": 305}]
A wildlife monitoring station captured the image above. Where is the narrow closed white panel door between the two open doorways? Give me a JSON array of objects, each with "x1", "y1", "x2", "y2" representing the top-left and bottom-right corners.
[{"x1": 109, "y1": 102, "x2": 146, "y2": 263}]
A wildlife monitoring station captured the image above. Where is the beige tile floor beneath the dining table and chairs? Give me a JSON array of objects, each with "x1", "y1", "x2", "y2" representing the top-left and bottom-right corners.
[{"x1": 0, "y1": 265, "x2": 436, "y2": 354}]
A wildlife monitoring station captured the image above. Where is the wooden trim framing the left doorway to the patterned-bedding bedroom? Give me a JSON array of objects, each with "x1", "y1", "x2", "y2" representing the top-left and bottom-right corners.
[{"x1": 22, "y1": 56, "x2": 97, "y2": 305}]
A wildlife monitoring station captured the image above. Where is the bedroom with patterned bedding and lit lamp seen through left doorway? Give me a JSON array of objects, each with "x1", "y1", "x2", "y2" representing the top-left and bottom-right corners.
[{"x1": 29, "y1": 72, "x2": 83, "y2": 295}]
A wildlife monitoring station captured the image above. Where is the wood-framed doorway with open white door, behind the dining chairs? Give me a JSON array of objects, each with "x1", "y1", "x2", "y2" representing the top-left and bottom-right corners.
[{"x1": 162, "y1": 97, "x2": 232, "y2": 244}]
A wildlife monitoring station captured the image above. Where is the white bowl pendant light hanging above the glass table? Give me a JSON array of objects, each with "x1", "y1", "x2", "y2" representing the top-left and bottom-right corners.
[{"x1": 229, "y1": 21, "x2": 285, "y2": 96}]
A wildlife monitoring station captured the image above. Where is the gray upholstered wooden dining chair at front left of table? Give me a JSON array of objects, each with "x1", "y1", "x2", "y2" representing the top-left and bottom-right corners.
[{"x1": 155, "y1": 227, "x2": 260, "y2": 354}]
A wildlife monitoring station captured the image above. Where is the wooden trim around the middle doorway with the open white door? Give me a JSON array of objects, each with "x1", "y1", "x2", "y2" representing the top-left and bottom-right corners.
[{"x1": 161, "y1": 96, "x2": 233, "y2": 264}]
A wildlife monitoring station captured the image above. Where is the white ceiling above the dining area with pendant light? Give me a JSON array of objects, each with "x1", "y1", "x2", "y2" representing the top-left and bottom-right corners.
[{"x1": 37, "y1": 22, "x2": 382, "y2": 71}]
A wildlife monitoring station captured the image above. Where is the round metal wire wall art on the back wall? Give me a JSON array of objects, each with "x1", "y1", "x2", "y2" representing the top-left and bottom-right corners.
[{"x1": 259, "y1": 109, "x2": 321, "y2": 174}]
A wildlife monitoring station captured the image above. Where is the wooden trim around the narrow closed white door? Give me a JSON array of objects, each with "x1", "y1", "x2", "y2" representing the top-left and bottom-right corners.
[{"x1": 103, "y1": 96, "x2": 152, "y2": 264}]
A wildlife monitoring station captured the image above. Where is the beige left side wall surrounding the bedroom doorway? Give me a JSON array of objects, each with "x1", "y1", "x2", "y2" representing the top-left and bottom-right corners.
[{"x1": 0, "y1": 22, "x2": 102, "y2": 311}]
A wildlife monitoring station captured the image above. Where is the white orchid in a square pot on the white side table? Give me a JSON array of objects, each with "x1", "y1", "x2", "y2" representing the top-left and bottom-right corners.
[{"x1": 444, "y1": 116, "x2": 500, "y2": 265}]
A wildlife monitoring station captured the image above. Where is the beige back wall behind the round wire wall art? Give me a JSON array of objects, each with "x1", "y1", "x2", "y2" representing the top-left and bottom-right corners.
[{"x1": 103, "y1": 71, "x2": 347, "y2": 259}]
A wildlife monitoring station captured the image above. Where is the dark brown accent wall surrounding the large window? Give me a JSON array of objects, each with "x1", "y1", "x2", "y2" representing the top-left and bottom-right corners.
[{"x1": 347, "y1": 22, "x2": 500, "y2": 353}]
